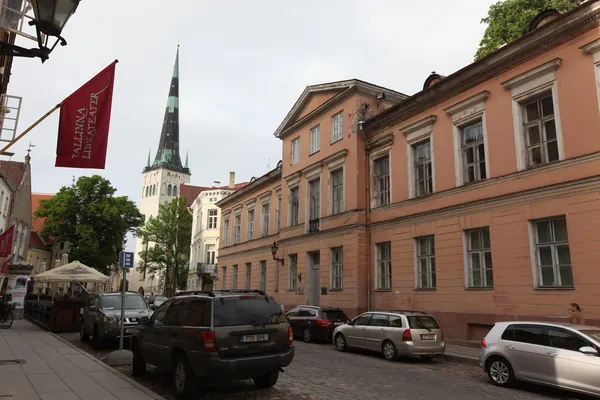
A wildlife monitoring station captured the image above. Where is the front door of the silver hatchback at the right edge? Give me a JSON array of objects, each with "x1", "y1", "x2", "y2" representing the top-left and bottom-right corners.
[{"x1": 548, "y1": 327, "x2": 600, "y2": 394}]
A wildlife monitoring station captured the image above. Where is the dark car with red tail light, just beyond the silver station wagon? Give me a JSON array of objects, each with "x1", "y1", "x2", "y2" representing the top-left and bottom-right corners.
[{"x1": 285, "y1": 305, "x2": 350, "y2": 343}]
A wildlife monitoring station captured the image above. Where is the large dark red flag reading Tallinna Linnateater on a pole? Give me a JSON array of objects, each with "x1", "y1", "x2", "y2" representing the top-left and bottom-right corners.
[{"x1": 55, "y1": 61, "x2": 118, "y2": 169}]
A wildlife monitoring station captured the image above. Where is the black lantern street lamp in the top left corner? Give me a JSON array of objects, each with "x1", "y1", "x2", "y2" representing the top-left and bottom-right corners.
[{"x1": 0, "y1": 0, "x2": 80, "y2": 63}]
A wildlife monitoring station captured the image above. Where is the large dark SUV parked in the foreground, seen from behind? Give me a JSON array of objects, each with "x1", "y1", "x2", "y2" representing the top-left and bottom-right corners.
[{"x1": 131, "y1": 290, "x2": 295, "y2": 398}]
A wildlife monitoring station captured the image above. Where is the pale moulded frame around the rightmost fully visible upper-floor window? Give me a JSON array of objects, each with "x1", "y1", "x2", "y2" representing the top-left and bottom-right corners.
[{"x1": 502, "y1": 58, "x2": 565, "y2": 171}]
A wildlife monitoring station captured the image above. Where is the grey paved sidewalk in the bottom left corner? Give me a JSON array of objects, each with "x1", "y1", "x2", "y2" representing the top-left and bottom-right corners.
[{"x1": 0, "y1": 320, "x2": 163, "y2": 400}]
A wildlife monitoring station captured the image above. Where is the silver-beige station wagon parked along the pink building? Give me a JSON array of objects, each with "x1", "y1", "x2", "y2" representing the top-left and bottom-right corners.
[{"x1": 333, "y1": 310, "x2": 446, "y2": 361}]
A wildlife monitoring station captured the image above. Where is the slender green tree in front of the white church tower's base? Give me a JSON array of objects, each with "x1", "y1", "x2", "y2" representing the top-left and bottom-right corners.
[{"x1": 137, "y1": 197, "x2": 192, "y2": 295}]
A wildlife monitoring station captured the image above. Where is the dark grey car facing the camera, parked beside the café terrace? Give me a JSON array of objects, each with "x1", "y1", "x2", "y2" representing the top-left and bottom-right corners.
[{"x1": 79, "y1": 292, "x2": 152, "y2": 346}]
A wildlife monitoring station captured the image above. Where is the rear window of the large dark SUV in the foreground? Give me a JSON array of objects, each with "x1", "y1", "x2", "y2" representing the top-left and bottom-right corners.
[{"x1": 214, "y1": 296, "x2": 287, "y2": 326}]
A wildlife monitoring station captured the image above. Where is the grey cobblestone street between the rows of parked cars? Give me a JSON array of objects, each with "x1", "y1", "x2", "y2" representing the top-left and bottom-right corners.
[{"x1": 60, "y1": 333, "x2": 584, "y2": 400}]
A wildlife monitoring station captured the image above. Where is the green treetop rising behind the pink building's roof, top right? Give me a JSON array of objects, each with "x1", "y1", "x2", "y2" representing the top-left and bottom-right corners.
[{"x1": 475, "y1": 0, "x2": 584, "y2": 60}]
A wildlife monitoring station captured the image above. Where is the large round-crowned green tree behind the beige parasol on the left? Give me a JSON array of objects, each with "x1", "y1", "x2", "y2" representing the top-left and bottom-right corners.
[{"x1": 35, "y1": 175, "x2": 144, "y2": 274}]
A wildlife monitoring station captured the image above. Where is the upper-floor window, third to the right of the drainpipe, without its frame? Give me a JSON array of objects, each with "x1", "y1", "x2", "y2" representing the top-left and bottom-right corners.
[{"x1": 460, "y1": 120, "x2": 487, "y2": 183}]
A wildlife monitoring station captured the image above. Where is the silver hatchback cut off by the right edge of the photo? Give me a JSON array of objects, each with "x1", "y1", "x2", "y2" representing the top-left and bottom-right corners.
[{"x1": 479, "y1": 321, "x2": 600, "y2": 395}]
